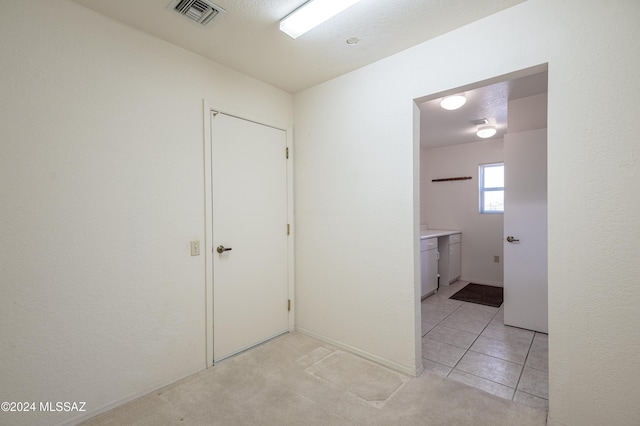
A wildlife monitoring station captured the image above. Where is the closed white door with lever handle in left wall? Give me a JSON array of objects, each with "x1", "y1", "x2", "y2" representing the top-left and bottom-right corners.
[{"x1": 211, "y1": 113, "x2": 288, "y2": 362}]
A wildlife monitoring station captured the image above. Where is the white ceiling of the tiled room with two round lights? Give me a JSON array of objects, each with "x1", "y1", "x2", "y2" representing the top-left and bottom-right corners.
[{"x1": 419, "y1": 71, "x2": 547, "y2": 148}]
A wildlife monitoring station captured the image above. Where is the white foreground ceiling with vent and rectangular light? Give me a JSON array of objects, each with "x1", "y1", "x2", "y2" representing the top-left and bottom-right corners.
[{"x1": 74, "y1": 0, "x2": 524, "y2": 93}]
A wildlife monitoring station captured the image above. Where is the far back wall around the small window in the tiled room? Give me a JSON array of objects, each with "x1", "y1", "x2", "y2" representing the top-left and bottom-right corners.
[{"x1": 420, "y1": 139, "x2": 504, "y2": 286}]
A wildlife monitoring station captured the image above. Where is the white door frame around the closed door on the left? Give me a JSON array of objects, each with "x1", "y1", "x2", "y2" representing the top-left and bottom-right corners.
[{"x1": 202, "y1": 99, "x2": 296, "y2": 368}]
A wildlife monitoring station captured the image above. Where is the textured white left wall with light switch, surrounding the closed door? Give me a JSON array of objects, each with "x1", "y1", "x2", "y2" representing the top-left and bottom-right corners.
[{"x1": 0, "y1": 0, "x2": 292, "y2": 424}]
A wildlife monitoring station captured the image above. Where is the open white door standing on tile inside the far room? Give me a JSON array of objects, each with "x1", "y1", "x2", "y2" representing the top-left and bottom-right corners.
[{"x1": 504, "y1": 129, "x2": 548, "y2": 333}]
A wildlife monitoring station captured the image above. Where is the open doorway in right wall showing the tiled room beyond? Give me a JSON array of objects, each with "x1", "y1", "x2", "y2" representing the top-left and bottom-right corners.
[{"x1": 415, "y1": 64, "x2": 548, "y2": 408}]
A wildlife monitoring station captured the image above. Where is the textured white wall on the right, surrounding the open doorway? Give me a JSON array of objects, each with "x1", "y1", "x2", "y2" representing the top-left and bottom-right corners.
[{"x1": 294, "y1": 0, "x2": 640, "y2": 425}]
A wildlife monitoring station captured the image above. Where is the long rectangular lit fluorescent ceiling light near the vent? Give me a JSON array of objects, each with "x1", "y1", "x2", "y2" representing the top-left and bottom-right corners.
[{"x1": 280, "y1": 0, "x2": 360, "y2": 39}]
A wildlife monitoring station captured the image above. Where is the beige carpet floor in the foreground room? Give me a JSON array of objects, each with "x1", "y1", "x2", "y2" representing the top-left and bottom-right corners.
[{"x1": 83, "y1": 333, "x2": 546, "y2": 426}]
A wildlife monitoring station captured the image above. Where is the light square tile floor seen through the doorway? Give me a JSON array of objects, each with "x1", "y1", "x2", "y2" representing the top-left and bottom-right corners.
[{"x1": 422, "y1": 281, "x2": 549, "y2": 410}]
